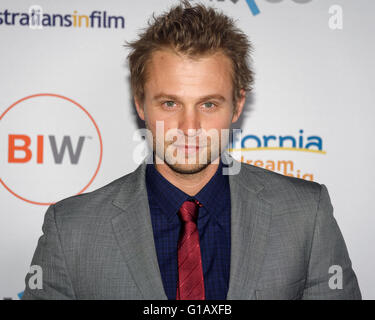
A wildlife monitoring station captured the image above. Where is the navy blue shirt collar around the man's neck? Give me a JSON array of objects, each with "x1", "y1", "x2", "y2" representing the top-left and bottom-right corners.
[{"x1": 146, "y1": 159, "x2": 229, "y2": 222}]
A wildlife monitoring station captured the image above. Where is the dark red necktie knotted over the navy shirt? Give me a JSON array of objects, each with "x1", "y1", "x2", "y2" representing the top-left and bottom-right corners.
[{"x1": 176, "y1": 200, "x2": 205, "y2": 300}]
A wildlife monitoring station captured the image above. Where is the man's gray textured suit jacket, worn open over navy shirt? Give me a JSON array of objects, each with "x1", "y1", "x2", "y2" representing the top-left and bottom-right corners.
[{"x1": 23, "y1": 156, "x2": 361, "y2": 299}]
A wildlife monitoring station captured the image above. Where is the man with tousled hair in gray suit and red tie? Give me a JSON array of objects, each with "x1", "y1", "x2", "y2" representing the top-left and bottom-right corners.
[{"x1": 23, "y1": 2, "x2": 361, "y2": 300}]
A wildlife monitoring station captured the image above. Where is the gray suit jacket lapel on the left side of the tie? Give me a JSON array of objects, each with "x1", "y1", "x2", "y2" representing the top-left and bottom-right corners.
[{"x1": 112, "y1": 163, "x2": 167, "y2": 300}]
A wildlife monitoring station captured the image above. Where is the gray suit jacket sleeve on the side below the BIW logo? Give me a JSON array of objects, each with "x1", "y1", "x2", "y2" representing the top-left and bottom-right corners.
[{"x1": 22, "y1": 206, "x2": 75, "y2": 300}]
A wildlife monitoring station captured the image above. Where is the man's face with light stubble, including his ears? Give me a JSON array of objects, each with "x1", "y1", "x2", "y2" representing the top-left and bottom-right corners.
[{"x1": 135, "y1": 50, "x2": 245, "y2": 173}]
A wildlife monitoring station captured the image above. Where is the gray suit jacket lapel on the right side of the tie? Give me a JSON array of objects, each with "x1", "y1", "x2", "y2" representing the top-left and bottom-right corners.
[{"x1": 227, "y1": 162, "x2": 272, "y2": 300}]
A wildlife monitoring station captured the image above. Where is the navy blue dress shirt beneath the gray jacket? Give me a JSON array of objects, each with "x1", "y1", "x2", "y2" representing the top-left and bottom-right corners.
[{"x1": 146, "y1": 162, "x2": 231, "y2": 300}]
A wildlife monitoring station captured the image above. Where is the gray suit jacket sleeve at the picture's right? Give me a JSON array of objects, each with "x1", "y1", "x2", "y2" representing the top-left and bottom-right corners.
[{"x1": 303, "y1": 185, "x2": 361, "y2": 300}]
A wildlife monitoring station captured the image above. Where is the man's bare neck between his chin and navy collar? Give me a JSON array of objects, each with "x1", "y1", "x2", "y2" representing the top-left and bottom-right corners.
[{"x1": 155, "y1": 157, "x2": 220, "y2": 196}]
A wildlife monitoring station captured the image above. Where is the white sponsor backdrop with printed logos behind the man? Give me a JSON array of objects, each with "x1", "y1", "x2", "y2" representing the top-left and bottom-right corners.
[{"x1": 0, "y1": 0, "x2": 375, "y2": 299}]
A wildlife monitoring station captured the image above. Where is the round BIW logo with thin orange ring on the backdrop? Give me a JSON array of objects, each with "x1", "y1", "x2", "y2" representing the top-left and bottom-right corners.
[{"x1": 0, "y1": 93, "x2": 103, "y2": 205}]
